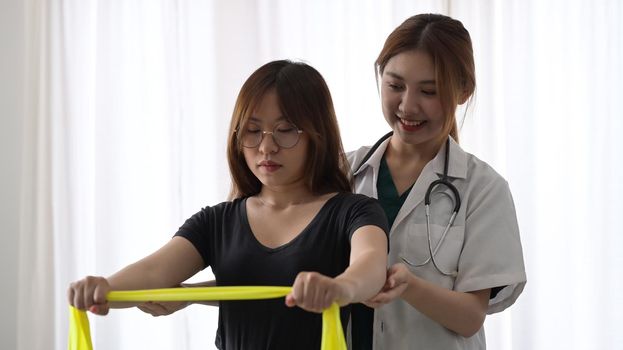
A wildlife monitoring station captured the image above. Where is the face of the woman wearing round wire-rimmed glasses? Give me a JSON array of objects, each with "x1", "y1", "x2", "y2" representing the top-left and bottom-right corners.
[{"x1": 242, "y1": 89, "x2": 308, "y2": 190}]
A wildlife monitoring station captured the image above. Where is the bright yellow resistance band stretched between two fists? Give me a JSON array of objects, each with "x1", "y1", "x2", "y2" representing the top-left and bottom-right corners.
[{"x1": 68, "y1": 286, "x2": 346, "y2": 350}]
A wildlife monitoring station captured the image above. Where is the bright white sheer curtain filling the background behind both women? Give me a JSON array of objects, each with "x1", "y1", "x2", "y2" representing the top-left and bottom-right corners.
[{"x1": 18, "y1": 0, "x2": 623, "y2": 350}]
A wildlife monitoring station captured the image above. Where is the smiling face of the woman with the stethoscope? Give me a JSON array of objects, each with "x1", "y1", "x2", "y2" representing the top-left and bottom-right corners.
[{"x1": 381, "y1": 50, "x2": 445, "y2": 148}]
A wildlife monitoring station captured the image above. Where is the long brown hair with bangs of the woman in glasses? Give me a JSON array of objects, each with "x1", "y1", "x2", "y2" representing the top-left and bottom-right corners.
[{"x1": 227, "y1": 60, "x2": 352, "y2": 199}]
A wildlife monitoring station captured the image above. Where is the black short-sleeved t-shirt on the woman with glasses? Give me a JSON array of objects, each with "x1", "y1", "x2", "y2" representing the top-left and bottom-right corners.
[{"x1": 176, "y1": 193, "x2": 388, "y2": 350}]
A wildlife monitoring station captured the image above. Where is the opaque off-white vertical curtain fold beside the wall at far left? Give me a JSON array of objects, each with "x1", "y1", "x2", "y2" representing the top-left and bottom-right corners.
[{"x1": 16, "y1": 1, "x2": 57, "y2": 349}]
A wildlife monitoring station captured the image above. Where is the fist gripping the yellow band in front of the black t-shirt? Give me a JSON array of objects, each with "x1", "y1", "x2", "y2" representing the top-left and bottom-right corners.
[{"x1": 286, "y1": 272, "x2": 352, "y2": 313}]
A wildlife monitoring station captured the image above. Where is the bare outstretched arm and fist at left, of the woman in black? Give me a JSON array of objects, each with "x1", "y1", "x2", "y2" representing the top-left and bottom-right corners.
[{"x1": 67, "y1": 237, "x2": 203, "y2": 315}]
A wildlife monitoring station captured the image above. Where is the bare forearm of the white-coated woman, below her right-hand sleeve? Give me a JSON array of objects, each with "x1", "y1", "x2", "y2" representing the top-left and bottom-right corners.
[{"x1": 402, "y1": 275, "x2": 490, "y2": 337}]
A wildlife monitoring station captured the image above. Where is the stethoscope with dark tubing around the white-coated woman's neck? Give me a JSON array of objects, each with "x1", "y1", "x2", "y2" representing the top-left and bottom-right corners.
[{"x1": 353, "y1": 131, "x2": 461, "y2": 277}]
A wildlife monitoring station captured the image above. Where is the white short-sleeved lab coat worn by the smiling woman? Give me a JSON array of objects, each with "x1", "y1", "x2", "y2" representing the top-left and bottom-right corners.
[{"x1": 347, "y1": 139, "x2": 526, "y2": 350}]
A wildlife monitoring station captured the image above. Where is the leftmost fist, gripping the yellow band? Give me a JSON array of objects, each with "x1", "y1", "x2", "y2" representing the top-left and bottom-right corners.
[{"x1": 67, "y1": 276, "x2": 110, "y2": 315}]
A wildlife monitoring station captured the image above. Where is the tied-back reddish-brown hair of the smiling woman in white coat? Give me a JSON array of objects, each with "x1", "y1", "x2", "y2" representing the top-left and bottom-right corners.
[{"x1": 375, "y1": 14, "x2": 476, "y2": 142}]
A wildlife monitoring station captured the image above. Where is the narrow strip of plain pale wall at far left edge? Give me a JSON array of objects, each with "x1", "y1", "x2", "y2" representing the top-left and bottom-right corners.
[{"x1": 0, "y1": 0, "x2": 24, "y2": 349}]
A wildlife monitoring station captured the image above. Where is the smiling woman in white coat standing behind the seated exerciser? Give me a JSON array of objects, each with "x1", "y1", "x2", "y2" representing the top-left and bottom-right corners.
[{"x1": 348, "y1": 14, "x2": 526, "y2": 350}]
